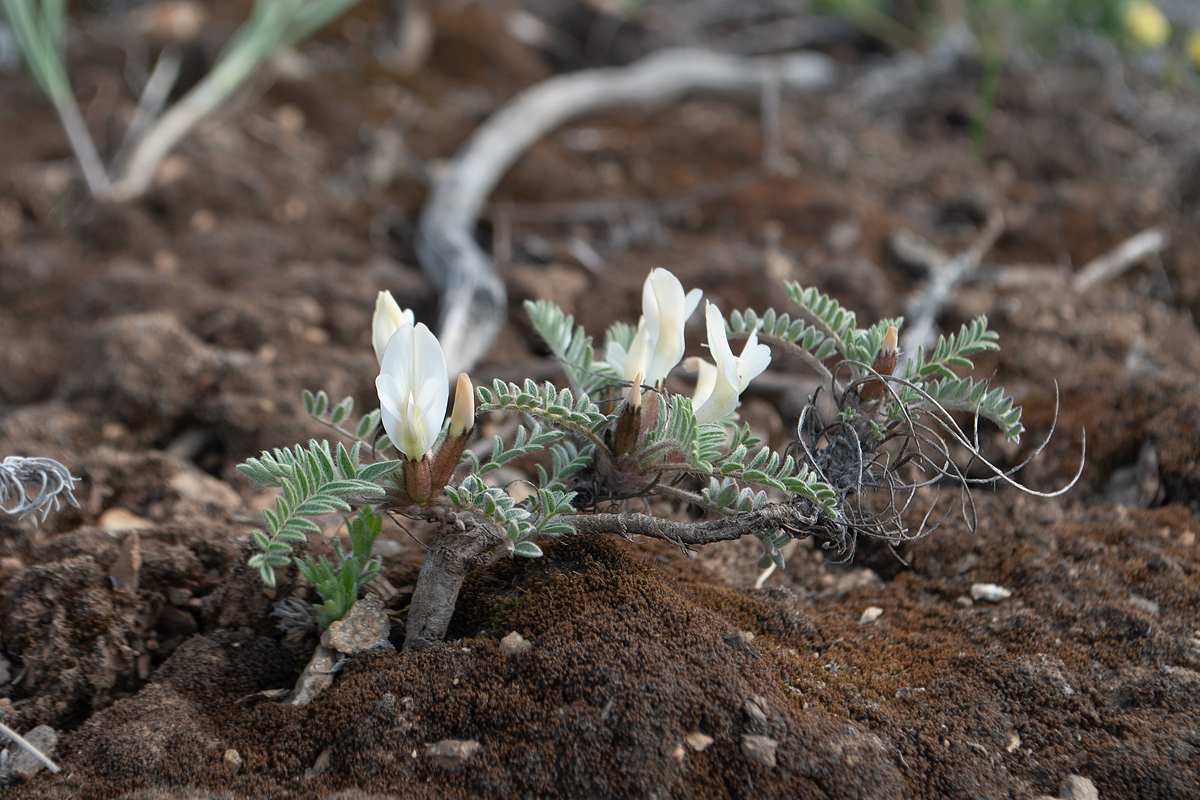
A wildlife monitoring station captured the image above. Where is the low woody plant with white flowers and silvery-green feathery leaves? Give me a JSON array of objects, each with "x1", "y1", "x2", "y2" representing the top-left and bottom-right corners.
[{"x1": 240, "y1": 269, "x2": 1078, "y2": 649}]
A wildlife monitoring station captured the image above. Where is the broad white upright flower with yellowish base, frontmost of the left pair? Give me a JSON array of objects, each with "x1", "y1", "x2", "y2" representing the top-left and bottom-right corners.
[{"x1": 376, "y1": 323, "x2": 450, "y2": 461}]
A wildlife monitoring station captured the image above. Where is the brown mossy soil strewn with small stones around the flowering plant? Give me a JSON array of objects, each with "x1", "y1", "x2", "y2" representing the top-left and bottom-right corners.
[{"x1": 0, "y1": 4, "x2": 1200, "y2": 800}]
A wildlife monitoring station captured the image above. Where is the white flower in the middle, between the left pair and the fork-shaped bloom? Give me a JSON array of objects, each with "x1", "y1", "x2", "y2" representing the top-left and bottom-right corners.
[{"x1": 605, "y1": 267, "x2": 703, "y2": 386}]
